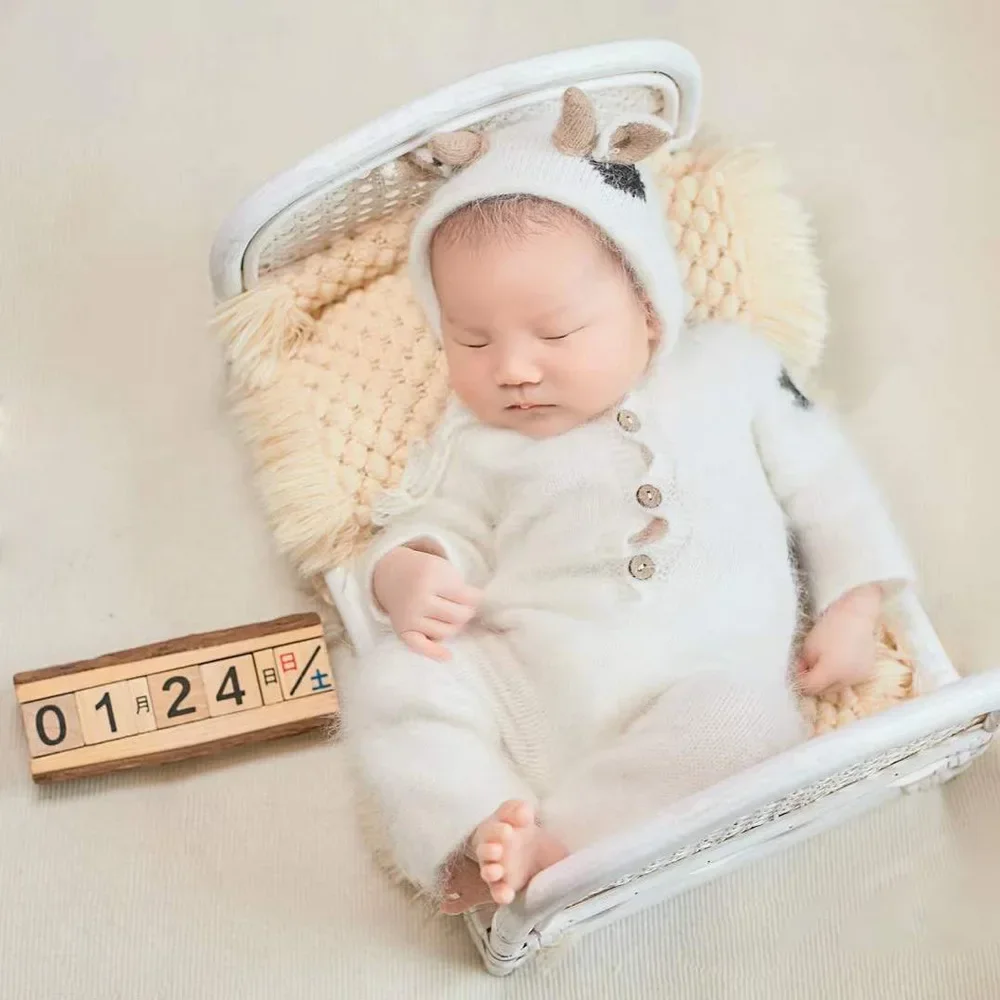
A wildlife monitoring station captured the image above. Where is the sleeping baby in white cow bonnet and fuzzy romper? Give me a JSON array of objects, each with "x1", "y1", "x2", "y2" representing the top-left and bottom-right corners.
[{"x1": 340, "y1": 89, "x2": 912, "y2": 912}]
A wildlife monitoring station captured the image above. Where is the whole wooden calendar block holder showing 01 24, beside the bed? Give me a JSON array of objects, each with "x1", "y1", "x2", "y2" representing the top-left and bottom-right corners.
[{"x1": 14, "y1": 614, "x2": 337, "y2": 781}]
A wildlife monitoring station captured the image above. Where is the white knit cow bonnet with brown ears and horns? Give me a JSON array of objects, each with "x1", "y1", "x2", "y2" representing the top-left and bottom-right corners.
[{"x1": 410, "y1": 87, "x2": 687, "y2": 349}]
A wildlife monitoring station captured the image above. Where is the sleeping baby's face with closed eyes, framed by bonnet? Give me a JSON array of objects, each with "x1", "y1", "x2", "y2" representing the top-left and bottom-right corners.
[{"x1": 431, "y1": 219, "x2": 658, "y2": 437}]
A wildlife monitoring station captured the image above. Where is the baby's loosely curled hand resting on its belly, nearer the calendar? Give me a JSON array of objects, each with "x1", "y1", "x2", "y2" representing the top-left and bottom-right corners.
[{"x1": 372, "y1": 545, "x2": 482, "y2": 660}]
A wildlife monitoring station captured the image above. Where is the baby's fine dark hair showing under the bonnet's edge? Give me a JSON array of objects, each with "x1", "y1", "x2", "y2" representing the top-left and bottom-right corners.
[{"x1": 431, "y1": 194, "x2": 651, "y2": 310}]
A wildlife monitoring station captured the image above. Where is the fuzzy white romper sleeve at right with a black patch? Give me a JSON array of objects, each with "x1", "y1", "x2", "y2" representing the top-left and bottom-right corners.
[{"x1": 753, "y1": 349, "x2": 915, "y2": 616}]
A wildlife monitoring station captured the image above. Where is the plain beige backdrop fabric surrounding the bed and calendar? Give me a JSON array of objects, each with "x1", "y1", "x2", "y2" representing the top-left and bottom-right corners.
[{"x1": 0, "y1": 0, "x2": 1000, "y2": 1000}]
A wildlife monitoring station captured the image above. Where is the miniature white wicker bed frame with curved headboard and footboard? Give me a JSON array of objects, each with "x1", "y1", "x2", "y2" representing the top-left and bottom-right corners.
[{"x1": 211, "y1": 41, "x2": 1000, "y2": 975}]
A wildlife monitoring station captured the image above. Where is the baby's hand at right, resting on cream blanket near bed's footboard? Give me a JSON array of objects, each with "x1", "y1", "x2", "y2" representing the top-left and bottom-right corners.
[{"x1": 796, "y1": 584, "x2": 882, "y2": 695}]
